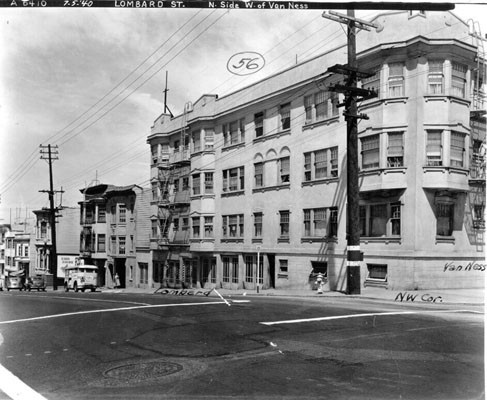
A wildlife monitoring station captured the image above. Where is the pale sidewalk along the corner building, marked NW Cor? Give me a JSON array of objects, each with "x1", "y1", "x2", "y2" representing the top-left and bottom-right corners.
[{"x1": 101, "y1": 287, "x2": 486, "y2": 305}]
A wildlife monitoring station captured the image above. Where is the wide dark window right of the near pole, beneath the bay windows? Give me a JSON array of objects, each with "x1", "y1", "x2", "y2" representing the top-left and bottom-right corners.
[{"x1": 359, "y1": 202, "x2": 401, "y2": 237}]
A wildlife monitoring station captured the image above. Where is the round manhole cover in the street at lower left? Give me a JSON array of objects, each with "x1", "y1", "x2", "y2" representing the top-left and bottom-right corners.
[{"x1": 104, "y1": 361, "x2": 183, "y2": 382}]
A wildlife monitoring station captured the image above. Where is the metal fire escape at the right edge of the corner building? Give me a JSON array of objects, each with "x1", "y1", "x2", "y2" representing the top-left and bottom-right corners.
[{"x1": 467, "y1": 21, "x2": 486, "y2": 251}]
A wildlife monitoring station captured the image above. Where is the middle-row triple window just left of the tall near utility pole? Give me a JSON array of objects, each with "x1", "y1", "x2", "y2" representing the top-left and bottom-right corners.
[{"x1": 304, "y1": 147, "x2": 338, "y2": 182}]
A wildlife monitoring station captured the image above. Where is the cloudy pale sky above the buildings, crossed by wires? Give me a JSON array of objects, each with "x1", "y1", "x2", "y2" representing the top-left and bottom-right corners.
[{"x1": 0, "y1": 0, "x2": 487, "y2": 224}]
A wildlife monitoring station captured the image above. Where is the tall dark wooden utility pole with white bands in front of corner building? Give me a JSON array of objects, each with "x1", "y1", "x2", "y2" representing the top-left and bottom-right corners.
[{"x1": 322, "y1": 10, "x2": 378, "y2": 294}]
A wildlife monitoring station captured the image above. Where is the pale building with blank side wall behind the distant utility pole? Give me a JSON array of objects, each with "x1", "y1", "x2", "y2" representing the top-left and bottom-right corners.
[{"x1": 29, "y1": 207, "x2": 80, "y2": 285}]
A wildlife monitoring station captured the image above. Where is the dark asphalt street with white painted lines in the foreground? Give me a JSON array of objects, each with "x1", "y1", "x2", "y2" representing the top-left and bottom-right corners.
[{"x1": 0, "y1": 291, "x2": 484, "y2": 400}]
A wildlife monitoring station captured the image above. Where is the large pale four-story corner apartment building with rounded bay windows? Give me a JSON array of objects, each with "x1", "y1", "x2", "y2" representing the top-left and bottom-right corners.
[{"x1": 148, "y1": 11, "x2": 486, "y2": 291}]
